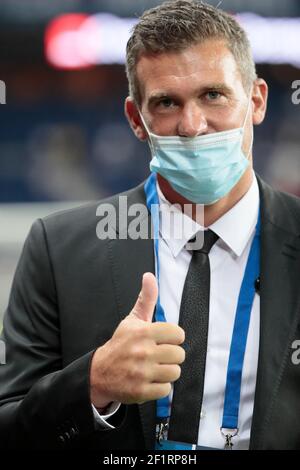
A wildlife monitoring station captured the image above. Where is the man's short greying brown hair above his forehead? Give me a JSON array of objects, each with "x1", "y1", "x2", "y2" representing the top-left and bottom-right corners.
[{"x1": 126, "y1": 0, "x2": 257, "y2": 104}]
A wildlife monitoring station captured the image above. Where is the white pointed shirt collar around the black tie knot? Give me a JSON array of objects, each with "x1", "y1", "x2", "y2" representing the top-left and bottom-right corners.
[{"x1": 156, "y1": 172, "x2": 259, "y2": 258}]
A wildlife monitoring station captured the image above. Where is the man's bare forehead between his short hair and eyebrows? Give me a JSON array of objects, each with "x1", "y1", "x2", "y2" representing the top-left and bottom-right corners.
[{"x1": 136, "y1": 40, "x2": 243, "y2": 100}]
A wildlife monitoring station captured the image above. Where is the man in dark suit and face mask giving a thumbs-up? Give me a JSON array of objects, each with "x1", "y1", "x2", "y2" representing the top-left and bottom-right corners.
[{"x1": 0, "y1": 0, "x2": 300, "y2": 450}]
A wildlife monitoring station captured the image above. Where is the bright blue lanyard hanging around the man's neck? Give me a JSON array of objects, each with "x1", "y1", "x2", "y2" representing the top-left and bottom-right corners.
[{"x1": 145, "y1": 173, "x2": 260, "y2": 431}]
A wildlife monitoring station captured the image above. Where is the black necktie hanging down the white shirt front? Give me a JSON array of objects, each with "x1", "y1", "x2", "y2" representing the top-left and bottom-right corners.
[{"x1": 168, "y1": 230, "x2": 218, "y2": 444}]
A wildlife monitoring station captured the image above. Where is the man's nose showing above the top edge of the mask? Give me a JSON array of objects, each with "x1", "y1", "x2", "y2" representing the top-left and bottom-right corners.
[{"x1": 178, "y1": 103, "x2": 207, "y2": 137}]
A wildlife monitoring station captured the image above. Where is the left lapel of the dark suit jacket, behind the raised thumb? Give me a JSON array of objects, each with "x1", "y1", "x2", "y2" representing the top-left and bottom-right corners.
[{"x1": 109, "y1": 184, "x2": 156, "y2": 449}]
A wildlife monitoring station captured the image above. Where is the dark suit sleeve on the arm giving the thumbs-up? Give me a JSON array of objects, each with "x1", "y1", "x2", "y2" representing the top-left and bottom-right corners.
[{"x1": 0, "y1": 220, "x2": 124, "y2": 449}]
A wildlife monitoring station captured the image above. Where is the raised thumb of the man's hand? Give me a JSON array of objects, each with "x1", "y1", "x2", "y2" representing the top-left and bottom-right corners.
[{"x1": 131, "y1": 273, "x2": 158, "y2": 322}]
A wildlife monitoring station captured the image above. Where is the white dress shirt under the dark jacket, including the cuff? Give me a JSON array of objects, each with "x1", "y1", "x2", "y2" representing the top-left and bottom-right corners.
[{"x1": 93, "y1": 173, "x2": 260, "y2": 449}]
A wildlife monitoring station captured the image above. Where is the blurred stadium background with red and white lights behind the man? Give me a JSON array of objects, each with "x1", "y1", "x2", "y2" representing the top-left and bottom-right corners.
[{"x1": 0, "y1": 0, "x2": 300, "y2": 320}]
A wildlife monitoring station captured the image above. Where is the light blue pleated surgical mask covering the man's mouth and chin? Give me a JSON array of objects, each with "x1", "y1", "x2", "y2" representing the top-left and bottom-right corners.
[{"x1": 140, "y1": 95, "x2": 253, "y2": 205}]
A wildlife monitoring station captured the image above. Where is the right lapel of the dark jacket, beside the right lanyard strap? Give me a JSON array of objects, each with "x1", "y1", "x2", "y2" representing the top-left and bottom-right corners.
[{"x1": 250, "y1": 180, "x2": 300, "y2": 449}]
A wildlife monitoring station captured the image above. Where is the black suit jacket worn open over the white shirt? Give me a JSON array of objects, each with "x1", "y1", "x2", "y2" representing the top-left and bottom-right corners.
[{"x1": 0, "y1": 174, "x2": 300, "y2": 450}]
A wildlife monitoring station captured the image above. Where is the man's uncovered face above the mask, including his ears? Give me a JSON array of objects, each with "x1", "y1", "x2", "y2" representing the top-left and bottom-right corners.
[{"x1": 126, "y1": 40, "x2": 266, "y2": 158}]
